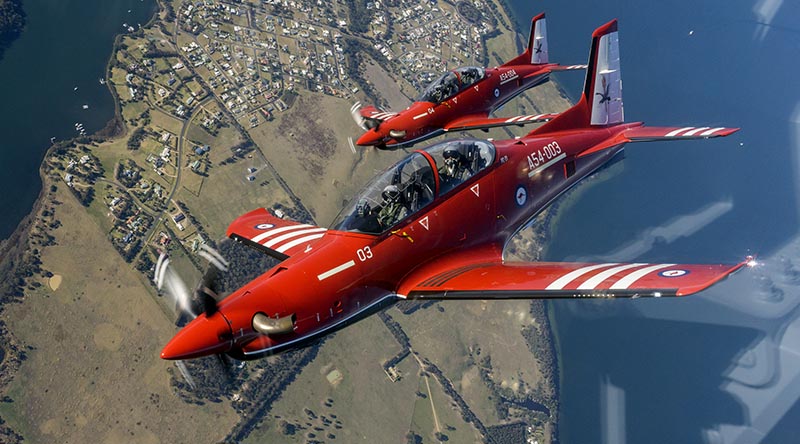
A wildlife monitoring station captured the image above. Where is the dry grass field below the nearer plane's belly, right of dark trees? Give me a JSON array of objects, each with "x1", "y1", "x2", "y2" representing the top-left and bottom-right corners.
[{"x1": 241, "y1": 316, "x2": 419, "y2": 443}]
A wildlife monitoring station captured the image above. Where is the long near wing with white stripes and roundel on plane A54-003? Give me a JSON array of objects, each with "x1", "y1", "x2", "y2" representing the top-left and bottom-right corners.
[{"x1": 397, "y1": 258, "x2": 752, "y2": 299}]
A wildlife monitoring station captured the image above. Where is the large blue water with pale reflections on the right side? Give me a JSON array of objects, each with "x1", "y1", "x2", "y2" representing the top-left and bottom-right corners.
[{"x1": 512, "y1": 0, "x2": 800, "y2": 444}]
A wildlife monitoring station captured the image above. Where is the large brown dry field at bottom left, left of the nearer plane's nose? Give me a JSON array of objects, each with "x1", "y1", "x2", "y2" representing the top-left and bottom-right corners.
[{"x1": 2, "y1": 186, "x2": 237, "y2": 443}]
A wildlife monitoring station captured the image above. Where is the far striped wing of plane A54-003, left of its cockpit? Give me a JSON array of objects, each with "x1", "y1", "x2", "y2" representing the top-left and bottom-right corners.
[{"x1": 227, "y1": 208, "x2": 328, "y2": 260}]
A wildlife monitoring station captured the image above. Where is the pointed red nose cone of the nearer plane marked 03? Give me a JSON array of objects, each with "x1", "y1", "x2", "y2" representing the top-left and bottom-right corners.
[{"x1": 161, "y1": 312, "x2": 232, "y2": 359}]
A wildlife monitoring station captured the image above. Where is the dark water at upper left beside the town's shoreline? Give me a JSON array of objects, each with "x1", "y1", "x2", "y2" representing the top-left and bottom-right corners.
[{"x1": 0, "y1": 0, "x2": 156, "y2": 239}]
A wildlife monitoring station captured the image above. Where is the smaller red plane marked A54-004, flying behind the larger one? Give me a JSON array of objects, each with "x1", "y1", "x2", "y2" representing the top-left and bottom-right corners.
[{"x1": 350, "y1": 13, "x2": 586, "y2": 148}]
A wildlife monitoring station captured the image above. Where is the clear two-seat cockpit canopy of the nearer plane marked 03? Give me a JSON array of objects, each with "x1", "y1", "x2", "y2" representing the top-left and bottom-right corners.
[{"x1": 331, "y1": 139, "x2": 495, "y2": 234}]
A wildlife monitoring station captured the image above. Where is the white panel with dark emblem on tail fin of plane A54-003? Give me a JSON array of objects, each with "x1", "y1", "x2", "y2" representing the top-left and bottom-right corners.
[{"x1": 586, "y1": 20, "x2": 625, "y2": 125}]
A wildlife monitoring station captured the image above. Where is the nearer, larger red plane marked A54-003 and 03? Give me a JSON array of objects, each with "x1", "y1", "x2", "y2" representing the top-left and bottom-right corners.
[{"x1": 161, "y1": 20, "x2": 753, "y2": 359}]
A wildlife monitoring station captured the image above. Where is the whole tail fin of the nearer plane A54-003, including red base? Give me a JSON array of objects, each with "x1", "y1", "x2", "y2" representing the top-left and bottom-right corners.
[{"x1": 530, "y1": 19, "x2": 625, "y2": 135}]
